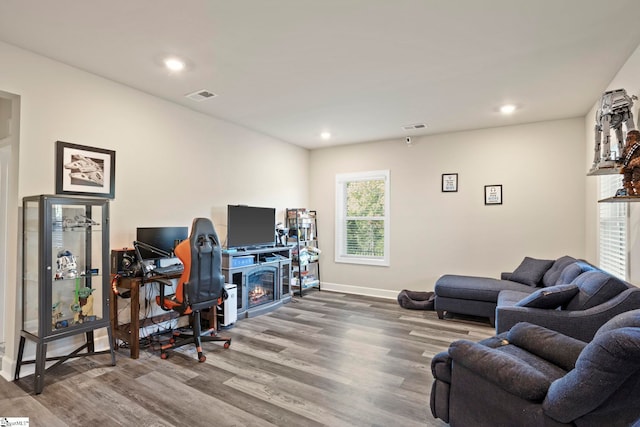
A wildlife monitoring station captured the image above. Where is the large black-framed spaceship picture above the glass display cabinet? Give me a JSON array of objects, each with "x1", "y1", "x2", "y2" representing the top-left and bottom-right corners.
[{"x1": 56, "y1": 141, "x2": 116, "y2": 199}]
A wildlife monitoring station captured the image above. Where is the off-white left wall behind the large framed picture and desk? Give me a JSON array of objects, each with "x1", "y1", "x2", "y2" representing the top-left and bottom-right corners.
[{"x1": 0, "y1": 43, "x2": 309, "y2": 380}]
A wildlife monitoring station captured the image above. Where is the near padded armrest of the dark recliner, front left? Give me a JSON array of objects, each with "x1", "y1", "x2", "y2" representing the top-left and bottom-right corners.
[{"x1": 449, "y1": 340, "x2": 552, "y2": 401}]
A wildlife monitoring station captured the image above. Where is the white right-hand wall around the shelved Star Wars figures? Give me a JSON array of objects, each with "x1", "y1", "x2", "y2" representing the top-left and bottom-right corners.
[{"x1": 584, "y1": 42, "x2": 640, "y2": 283}]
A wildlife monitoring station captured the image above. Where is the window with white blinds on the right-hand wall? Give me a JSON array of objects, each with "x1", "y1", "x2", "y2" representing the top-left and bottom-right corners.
[{"x1": 598, "y1": 175, "x2": 628, "y2": 279}]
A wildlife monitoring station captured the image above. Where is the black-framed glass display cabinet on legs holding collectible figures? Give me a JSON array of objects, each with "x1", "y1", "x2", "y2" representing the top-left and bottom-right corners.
[{"x1": 15, "y1": 195, "x2": 115, "y2": 394}]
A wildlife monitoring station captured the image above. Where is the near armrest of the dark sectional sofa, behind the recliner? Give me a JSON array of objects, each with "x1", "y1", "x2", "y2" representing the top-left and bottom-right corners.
[{"x1": 496, "y1": 287, "x2": 640, "y2": 342}]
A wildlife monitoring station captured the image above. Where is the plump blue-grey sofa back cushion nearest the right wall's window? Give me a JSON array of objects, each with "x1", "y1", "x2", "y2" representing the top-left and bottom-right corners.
[{"x1": 566, "y1": 270, "x2": 627, "y2": 310}]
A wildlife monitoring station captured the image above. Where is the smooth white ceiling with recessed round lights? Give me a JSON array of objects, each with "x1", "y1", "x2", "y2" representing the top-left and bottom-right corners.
[{"x1": 0, "y1": 0, "x2": 640, "y2": 148}]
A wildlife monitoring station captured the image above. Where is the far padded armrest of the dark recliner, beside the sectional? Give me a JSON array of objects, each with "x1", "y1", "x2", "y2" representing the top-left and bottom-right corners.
[{"x1": 507, "y1": 322, "x2": 587, "y2": 371}]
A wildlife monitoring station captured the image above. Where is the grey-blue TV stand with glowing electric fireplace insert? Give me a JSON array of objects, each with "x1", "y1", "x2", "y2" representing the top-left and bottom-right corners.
[{"x1": 222, "y1": 246, "x2": 291, "y2": 319}]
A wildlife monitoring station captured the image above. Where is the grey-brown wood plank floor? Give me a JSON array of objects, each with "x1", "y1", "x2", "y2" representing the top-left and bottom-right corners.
[{"x1": 0, "y1": 291, "x2": 493, "y2": 427}]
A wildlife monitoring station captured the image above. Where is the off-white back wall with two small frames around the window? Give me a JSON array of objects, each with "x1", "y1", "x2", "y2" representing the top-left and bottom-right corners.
[{"x1": 310, "y1": 118, "x2": 585, "y2": 297}]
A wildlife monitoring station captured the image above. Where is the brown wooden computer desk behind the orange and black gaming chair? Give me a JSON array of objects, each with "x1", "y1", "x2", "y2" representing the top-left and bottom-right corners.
[{"x1": 109, "y1": 273, "x2": 218, "y2": 359}]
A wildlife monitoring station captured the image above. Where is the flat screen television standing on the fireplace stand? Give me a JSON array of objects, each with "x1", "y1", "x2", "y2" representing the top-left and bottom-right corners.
[{"x1": 227, "y1": 205, "x2": 276, "y2": 249}]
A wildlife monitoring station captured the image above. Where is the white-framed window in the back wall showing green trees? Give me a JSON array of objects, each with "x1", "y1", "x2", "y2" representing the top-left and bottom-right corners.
[{"x1": 336, "y1": 170, "x2": 389, "y2": 266}]
